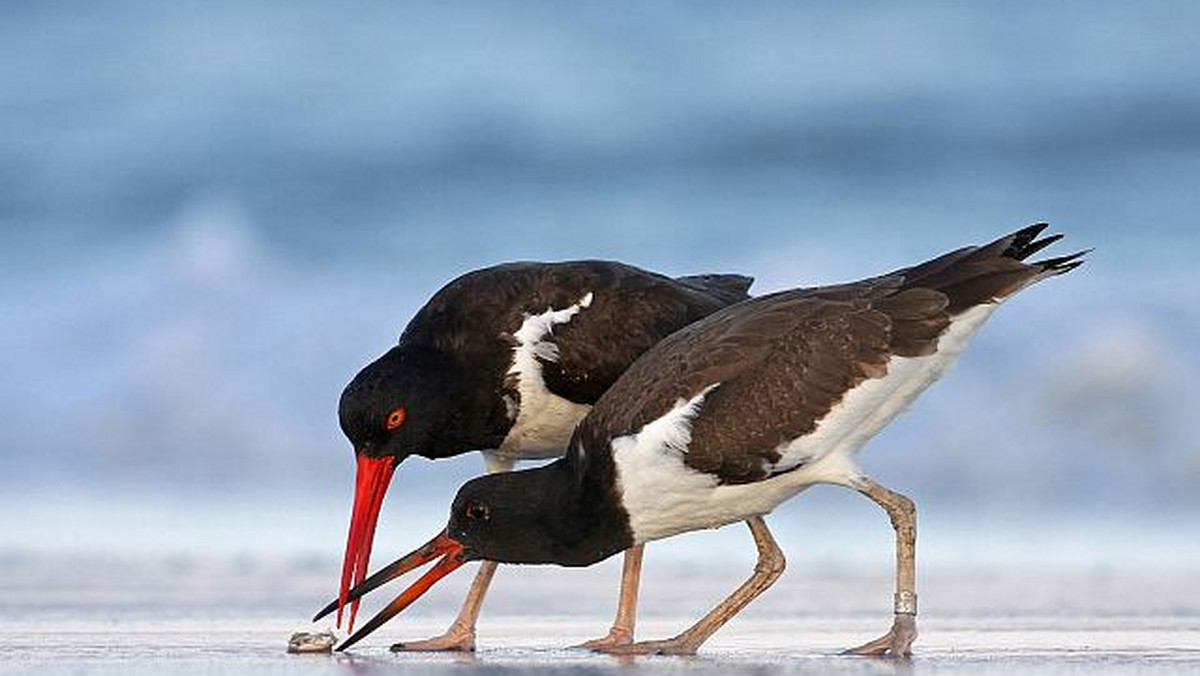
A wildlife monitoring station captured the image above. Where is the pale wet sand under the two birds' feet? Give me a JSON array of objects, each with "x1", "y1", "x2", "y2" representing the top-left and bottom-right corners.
[{"x1": 0, "y1": 558, "x2": 1200, "y2": 675}]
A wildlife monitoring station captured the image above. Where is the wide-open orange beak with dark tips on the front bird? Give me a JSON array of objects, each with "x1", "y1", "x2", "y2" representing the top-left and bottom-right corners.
[{"x1": 312, "y1": 531, "x2": 467, "y2": 651}]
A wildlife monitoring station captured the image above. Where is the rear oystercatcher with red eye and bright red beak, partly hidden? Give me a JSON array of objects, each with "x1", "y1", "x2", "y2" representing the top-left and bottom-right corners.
[{"x1": 313, "y1": 261, "x2": 754, "y2": 651}]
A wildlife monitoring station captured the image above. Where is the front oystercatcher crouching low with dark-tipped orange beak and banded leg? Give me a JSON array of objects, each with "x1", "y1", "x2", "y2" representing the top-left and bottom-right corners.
[{"x1": 338, "y1": 223, "x2": 1086, "y2": 656}]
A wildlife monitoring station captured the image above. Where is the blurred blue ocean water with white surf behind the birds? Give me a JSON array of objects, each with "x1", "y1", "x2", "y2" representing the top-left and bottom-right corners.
[{"x1": 0, "y1": 0, "x2": 1200, "y2": 672}]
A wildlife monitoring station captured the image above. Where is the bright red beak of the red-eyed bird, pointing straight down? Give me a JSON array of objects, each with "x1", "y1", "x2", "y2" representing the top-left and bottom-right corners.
[{"x1": 335, "y1": 453, "x2": 396, "y2": 632}]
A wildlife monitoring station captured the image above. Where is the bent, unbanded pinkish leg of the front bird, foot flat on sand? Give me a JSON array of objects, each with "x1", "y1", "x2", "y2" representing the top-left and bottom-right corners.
[{"x1": 601, "y1": 516, "x2": 786, "y2": 654}]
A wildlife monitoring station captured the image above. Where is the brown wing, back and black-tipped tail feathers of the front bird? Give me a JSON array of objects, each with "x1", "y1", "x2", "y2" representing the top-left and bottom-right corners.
[{"x1": 584, "y1": 223, "x2": 1086, "y2": 483}]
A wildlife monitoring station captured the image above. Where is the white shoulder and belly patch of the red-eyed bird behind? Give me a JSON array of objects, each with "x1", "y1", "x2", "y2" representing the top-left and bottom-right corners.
[{"x1": 496, "y1": 292, "x2": 593, "y2": 459}]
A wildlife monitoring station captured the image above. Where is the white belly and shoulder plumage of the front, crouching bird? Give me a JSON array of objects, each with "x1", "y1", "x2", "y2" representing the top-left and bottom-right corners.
[{"x1": 612, "y1": 305, "x2": 996, "y2": 544}]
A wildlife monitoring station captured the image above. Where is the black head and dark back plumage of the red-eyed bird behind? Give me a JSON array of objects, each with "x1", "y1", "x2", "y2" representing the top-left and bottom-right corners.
[{"x1": 340, "y1": 261, "x2": 752, "y2": 457}]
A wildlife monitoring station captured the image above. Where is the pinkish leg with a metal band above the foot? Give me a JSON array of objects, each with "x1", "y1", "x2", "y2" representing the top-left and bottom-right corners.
[{"x1": 846, "y1": 477, "x2": 917, "y2": 657}]
